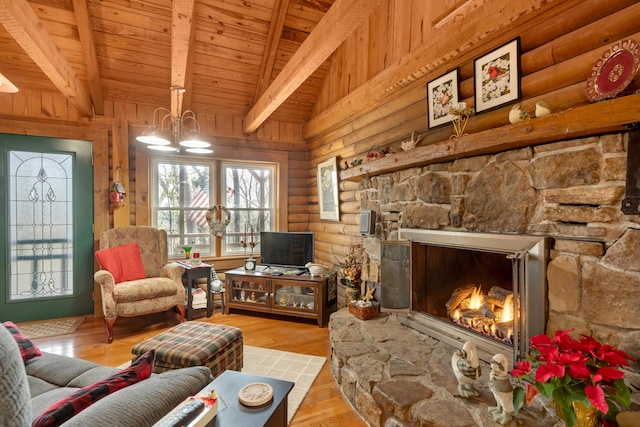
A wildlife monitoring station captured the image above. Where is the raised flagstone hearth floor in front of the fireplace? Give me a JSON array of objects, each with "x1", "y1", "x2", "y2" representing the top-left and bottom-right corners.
[{"x1": 329, "y1": 309, "x2": 556, "y2": 427}]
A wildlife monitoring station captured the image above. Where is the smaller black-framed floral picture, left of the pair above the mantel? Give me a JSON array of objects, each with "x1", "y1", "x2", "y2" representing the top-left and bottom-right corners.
[{"x1": 427, "y1": 68, "x2": 460, "y2": 128}]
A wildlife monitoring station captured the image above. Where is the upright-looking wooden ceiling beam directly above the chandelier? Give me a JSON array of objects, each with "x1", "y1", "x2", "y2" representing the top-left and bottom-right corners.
[{"x1": 171, "y1": 0, "x2": 196, "y2": 117}]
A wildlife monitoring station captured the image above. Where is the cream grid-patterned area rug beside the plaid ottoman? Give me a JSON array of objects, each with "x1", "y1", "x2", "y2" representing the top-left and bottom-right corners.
[{"x1": 118, "y1": 344, "x2": 327, "y2": 424}]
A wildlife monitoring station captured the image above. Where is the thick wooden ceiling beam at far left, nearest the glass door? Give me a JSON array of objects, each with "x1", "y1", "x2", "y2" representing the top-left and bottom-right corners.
[{"x1": 0, "y1": 0, "x2": 92, "y2": 117}]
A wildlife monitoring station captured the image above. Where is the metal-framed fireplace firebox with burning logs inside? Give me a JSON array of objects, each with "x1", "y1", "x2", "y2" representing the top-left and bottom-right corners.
[{"x1": 399, "y1": 229, "x2": 548, "y2": 361}]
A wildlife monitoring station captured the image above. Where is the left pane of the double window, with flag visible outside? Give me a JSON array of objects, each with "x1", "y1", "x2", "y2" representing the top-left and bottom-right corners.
[{"x1": 152, "y1": 159, "x2": 215, "y2": 257}]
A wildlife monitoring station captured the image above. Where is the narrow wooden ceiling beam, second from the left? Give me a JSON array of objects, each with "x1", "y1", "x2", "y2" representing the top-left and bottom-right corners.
[{"x1": 73, "y1": 0, "x2": 104, "y2": 116}]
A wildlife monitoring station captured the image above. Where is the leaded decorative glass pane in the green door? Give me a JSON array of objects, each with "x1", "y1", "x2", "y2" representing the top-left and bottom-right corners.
[{"x1": 8, "y1": 151, "x2": 74, "y2": 301}]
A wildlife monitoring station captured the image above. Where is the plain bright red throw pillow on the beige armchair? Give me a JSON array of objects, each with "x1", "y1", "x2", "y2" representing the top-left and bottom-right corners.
[{"x1": 96, "y1": 243, "x2": 147, "y2": 283}]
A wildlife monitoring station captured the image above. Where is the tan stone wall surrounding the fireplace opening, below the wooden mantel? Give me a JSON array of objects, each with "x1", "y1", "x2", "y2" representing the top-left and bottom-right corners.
[{"x1": 358, "y1": 133, "x2": 640, "y2": 371}]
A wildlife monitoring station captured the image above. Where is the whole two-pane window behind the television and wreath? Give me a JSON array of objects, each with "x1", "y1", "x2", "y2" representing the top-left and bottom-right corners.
[{"x1": 152, "y1": 156, "x2": 276, "y2": 257}]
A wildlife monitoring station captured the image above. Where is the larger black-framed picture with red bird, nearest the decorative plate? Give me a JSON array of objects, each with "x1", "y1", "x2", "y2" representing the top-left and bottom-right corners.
[{"x1": 473, "y1": 38, "x2": 520, "y2": 113}]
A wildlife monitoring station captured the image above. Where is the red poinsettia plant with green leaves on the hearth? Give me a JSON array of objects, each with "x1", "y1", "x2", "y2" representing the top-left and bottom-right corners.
[{"x1": 510, "y1": 329, "x2": 633, "y2": 427}]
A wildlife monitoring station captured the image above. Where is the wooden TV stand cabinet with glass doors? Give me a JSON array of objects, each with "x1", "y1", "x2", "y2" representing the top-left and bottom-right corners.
[{"x1": 224, "y1": 268, "x2": 337, "y2": 327}]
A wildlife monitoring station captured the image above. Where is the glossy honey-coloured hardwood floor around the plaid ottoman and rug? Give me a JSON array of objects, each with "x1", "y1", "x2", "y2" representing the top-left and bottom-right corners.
[{"x1": 34, "y1": 309, "x2": 366, "y2": 427}]
